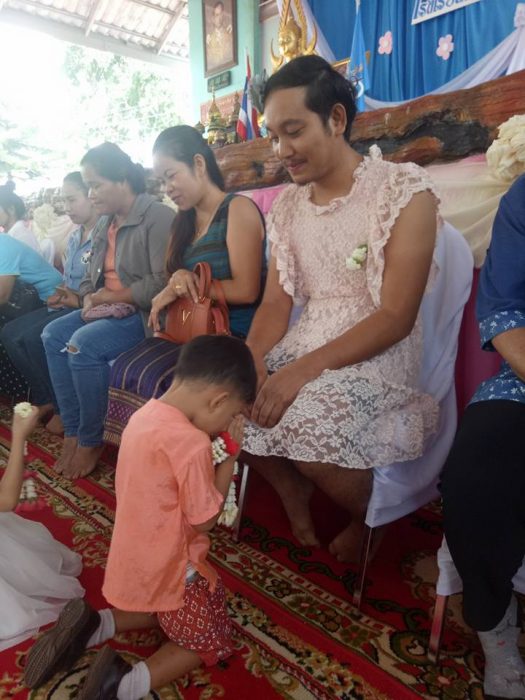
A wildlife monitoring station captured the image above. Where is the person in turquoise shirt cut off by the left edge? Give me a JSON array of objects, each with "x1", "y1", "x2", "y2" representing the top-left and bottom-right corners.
[{"x1": 0, "y1": 234, "x2": 62, "y2": 399}]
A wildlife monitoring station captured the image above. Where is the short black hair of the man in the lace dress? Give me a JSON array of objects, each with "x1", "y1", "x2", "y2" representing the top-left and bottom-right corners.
[{"x1": 263, "y1": 56, "x2": 357, "y2": 143}]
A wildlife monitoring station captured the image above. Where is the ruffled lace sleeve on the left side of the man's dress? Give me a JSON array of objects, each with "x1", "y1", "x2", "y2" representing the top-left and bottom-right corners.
[{"x1": 267, "y1": 185, "x2": 304, "y2": 304}]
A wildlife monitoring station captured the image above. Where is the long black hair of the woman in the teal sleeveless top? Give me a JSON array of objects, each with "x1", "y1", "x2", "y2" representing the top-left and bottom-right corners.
[{"x1": 153, "y1": 124, "x2": 224, "y2": 275}]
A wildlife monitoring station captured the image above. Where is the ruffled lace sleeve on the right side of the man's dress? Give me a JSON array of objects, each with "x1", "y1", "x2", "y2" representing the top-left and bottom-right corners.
[{"x1": 366, "y1": 161, "x2": 442, "y2": 306}]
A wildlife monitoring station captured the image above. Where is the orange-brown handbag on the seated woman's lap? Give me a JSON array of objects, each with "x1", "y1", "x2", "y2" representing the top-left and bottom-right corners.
[{"x1": 154, "y1": 262, "x2": 230, "y2": 345}]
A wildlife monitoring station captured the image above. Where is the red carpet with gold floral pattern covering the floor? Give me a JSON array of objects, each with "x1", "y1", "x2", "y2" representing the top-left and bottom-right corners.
[{"x1": 0, "y1": 406, "x2": 483, "y2": 700}]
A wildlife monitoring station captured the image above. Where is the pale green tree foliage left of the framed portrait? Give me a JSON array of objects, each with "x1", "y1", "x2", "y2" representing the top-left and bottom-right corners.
[{"x1": 64, "y1": 46, "x2": 180, "y2": 147}]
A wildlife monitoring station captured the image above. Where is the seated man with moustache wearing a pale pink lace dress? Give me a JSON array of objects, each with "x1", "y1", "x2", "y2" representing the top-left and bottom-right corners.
[{"x1": 244, "y1": 56, "x2": 438, "y2": 561}]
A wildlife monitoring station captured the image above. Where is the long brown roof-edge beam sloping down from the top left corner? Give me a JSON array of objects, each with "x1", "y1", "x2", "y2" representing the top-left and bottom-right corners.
[{"x1": 1, "y1": 7, "x2": 188, "y2": 69}]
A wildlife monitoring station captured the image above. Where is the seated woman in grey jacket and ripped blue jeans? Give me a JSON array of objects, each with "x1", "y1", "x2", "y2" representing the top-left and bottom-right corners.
[{"x1": 42, "y1": 143, "x2": 174, "y2": 479}]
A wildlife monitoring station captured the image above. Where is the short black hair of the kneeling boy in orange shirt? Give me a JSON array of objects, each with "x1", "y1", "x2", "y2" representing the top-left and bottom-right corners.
[{"x1": 174, "y1": 335, "x2": 257, "y2": 403}]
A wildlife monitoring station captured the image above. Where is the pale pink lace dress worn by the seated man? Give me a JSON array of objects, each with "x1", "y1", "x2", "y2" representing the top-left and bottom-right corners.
[{"x1": 244, "y1": 147, "x2": 439, "y2": 469}]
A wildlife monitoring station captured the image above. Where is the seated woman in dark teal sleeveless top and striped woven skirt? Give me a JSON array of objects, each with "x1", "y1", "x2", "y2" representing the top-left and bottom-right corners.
[{"x1": 104, "y1": 125, "x2": 264, "y2": 445}]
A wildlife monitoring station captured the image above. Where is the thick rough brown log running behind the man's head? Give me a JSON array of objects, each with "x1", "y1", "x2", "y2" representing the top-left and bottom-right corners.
[{"x1": 215, "y1": 70, "x2": 525, "y2": 192}]
